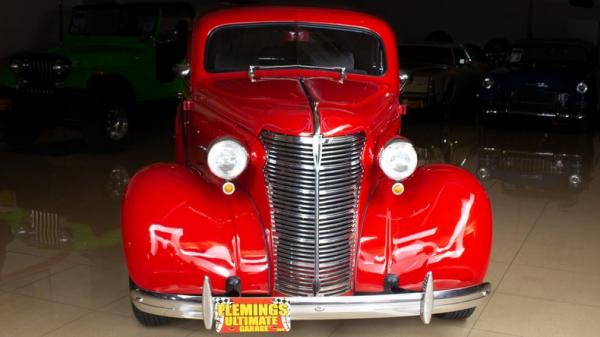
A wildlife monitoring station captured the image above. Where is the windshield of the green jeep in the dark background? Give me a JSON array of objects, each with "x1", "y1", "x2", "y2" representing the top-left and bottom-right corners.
[{"x1": 70, "y1": 6, "x2": 158, "y2": 36}]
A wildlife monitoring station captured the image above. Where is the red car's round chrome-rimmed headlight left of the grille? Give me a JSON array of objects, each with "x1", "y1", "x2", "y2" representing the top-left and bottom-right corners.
[{"x1": 207, "y1": 138, "x2": 248, "y2": 180}]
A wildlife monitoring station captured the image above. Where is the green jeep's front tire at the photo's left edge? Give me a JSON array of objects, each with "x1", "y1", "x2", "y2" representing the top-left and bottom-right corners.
[{"x1": 3, "y1": 105, "x2": 44, "y2": 150}]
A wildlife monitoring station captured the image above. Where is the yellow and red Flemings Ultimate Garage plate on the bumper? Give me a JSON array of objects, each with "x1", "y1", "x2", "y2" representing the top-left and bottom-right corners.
[{"x1": 213, "y1": 297, "x2": 291, "y2": 333}]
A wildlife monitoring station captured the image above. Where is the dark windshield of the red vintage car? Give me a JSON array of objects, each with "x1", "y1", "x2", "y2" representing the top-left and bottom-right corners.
[{"x1": 205, "y1": 24, "x2": 385, "y2": 75}]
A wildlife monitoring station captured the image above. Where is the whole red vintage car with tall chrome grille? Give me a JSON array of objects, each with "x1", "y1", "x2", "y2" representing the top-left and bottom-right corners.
[{"x1": 122, "y1": 7, "x2": 492, "y2": 332}]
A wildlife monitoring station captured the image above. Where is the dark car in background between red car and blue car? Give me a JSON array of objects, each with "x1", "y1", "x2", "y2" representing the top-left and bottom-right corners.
[{"x1": 398, "y1": 44, "x2": 488, "y2": 117}]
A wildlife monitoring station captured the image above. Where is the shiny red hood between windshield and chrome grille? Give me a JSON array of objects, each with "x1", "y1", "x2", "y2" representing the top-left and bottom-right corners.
[{"x1": 199, "y1": 78, "x2": 400, "y2": 137}]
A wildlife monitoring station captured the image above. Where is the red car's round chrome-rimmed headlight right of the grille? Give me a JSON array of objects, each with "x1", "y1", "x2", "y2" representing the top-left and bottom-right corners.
[{"x1": 379, "y1": 138, "x2": 417, "y2": 181}]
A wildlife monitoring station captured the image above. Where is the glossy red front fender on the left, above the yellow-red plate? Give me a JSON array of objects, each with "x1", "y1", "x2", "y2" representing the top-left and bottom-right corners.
[{"x1": 121, "y1": 164, "x2": 270, "y2": 294}]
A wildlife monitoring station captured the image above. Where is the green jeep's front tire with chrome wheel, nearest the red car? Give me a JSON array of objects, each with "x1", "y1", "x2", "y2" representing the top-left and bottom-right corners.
[{"x1": 82, "y1": 91, "x2": 134, "y2": 152}]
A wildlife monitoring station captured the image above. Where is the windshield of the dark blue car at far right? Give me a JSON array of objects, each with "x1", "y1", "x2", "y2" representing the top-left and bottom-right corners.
[{"x1": 508, "y1": 45, "x2": 590, "y2": 68}]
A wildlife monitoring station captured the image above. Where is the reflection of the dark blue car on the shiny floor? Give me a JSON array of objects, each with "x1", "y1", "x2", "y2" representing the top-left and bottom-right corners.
[{"x1": 477, "y1": 123, "x2": 596, "y2": 192}]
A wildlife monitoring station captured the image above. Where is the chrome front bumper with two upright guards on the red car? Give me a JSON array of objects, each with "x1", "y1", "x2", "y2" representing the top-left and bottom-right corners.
[{"x1": 130, "y1": 273, "x2": 491, "y2": 329}]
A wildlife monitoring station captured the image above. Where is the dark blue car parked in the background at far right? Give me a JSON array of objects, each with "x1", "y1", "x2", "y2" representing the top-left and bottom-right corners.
[{"x1": 480, "y1": 39, "x2": 598, "y2": 126}]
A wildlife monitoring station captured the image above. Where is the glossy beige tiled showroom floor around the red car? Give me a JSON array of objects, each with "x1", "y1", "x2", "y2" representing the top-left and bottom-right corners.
[{"x1": 0, "y1": 113, "x2": 600, "y2": 337}]
